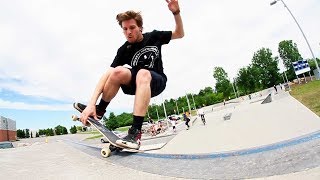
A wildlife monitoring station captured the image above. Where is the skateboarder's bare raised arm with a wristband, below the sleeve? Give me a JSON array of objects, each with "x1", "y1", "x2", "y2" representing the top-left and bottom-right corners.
[{"x1": 166, "y1": 0, "x2": 184, "y2": 39}]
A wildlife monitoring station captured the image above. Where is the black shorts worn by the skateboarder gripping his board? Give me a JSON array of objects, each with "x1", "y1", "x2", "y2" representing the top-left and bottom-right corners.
[{"x1": 121, "y1": 69, "x2": 167, "y2": 97}]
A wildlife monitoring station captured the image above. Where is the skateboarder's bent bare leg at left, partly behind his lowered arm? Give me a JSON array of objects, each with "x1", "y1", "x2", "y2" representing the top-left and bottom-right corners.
[{"x1": 102, "y1": 66, "x2": 131, "y2": 102}]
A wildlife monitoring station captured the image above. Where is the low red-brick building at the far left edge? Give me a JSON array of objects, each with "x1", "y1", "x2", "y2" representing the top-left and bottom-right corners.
[{"x1": 0, "y1": 116, "x2": 17, "y2": 142}]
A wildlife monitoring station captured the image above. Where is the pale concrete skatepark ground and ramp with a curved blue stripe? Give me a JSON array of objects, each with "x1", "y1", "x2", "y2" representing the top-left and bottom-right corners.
[{"x1": 0, "y1": 89, "x2": 320, "y2": 179}]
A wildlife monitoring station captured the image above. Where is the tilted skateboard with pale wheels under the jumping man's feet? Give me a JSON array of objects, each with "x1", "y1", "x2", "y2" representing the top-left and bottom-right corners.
[{"x1": 72, "y1": 115, "x2": 144, "y2": 158}]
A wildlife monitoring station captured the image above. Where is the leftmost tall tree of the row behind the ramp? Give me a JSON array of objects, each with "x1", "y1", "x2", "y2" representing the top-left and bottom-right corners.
[{"x1": 213, "y1": 67, "x2": 232, "y2": 98}]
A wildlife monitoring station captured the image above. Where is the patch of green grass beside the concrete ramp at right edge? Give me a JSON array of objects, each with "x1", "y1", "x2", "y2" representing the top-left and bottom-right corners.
[{"x1": 290, "y1": 80, "x2": 320, "y2": 116}]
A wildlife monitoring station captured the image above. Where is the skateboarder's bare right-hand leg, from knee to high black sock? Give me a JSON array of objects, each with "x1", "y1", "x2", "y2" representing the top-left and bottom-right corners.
[{"x1": 133, "y1": 69, "x2": 152, "y2": 116}]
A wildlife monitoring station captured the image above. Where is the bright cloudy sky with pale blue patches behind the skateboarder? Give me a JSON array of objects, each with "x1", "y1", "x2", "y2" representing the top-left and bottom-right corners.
[{"x1": 0, "y1": 0, "x2": 320, "y2": 130}]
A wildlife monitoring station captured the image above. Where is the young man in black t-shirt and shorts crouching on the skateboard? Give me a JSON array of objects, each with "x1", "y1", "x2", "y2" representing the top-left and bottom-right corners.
[{"x1": 74, "y1": 0, "x2": 184, "y2": 149}]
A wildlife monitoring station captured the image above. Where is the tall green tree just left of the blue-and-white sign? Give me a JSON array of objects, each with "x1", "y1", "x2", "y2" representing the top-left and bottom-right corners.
[{"x1": 278, "y1": 40, "x2": 303, "y2": 80}]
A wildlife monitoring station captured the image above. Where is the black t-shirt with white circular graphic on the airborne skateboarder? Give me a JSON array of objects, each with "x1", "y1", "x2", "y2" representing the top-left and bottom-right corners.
[{"x1": 111, "y1": 30, "x2": 172, "y2": 78}]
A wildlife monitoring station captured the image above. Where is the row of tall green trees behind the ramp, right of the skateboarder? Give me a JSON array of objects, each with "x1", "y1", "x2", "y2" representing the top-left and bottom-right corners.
[{"x1": 213, "y1": 40, "x2": 320, "y2": 98}]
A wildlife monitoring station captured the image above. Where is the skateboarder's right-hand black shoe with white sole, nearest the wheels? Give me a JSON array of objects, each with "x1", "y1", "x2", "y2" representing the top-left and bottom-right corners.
[{"x1": 116, "y1": 127, "x2": 141, "y2": 149}]
